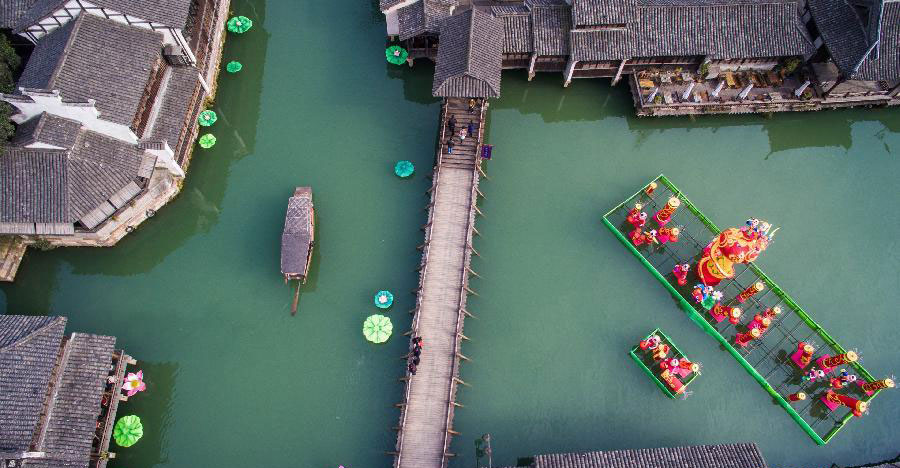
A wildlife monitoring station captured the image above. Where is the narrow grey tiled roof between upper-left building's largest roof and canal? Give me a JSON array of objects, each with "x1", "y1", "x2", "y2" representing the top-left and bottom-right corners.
[{"x1": 149, "y1": 67, "x2": 200, "y2": 154}]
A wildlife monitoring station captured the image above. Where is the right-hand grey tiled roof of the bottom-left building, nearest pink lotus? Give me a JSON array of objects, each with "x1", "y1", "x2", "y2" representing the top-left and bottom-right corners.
[{"x1": 38, "y1": 333, "x2": 116, "y2": 467}]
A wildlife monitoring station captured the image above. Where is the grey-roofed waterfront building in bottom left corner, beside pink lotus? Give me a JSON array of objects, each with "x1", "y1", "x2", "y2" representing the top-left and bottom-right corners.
[{"x1": 0, "y1": 315, "x2": 134, "y2": 468}]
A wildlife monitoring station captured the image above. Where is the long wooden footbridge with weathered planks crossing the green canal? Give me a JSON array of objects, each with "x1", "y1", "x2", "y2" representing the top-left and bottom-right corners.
[{"x1": 392, "y1": 98, "x2": 487, "y2": 468}]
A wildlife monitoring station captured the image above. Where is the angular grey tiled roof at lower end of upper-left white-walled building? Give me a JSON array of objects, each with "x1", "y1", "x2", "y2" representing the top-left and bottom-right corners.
[{"x1": 0, "y1": 129, "x2": 144, "y2": 227}]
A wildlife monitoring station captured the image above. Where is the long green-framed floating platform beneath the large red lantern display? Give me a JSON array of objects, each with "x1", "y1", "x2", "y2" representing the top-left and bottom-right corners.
[{"x1": 603, "y1": 175, "x2": 880, "y2": 445}]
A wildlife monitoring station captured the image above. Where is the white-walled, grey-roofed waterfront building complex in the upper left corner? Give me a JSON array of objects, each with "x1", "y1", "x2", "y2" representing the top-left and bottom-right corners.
[{"x1": 0, "y1": 0, "x2": 229, "y2": 280}]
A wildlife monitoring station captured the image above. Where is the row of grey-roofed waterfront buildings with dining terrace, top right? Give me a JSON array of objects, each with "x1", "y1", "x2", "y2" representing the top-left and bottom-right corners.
[{"x1": 380, "y1": 0, "x2": 900, "y2": 110}]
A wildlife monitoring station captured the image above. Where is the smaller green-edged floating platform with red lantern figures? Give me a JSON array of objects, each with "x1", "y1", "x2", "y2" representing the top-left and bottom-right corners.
[{"x1": 628, "y1": 328, "x2": 700, "y2": 398}]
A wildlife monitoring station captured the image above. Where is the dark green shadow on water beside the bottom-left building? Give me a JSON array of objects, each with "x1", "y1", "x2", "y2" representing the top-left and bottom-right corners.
[{"x1": 109, "y1": 360, "x2": 178, "y2": 468}]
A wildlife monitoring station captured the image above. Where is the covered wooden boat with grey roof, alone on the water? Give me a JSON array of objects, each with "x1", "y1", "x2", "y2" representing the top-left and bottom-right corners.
[{"x1": 281, "y1": 187, "x2": 316, "y2": 315}]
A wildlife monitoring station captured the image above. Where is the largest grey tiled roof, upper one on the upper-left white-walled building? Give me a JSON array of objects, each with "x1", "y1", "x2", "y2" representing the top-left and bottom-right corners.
[{"x1": 18, "y1": 14, "x2": 162, "y2": 125}]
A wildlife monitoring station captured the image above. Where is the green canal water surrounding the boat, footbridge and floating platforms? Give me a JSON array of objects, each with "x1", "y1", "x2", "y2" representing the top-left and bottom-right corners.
[{"x1": 0, "y1": 0, "x2": 900, "y2": 468}]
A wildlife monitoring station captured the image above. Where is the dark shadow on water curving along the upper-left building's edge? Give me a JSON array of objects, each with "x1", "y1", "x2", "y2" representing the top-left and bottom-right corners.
[{"x1": 0, "y1": 1, "x2": 270, "y2": 306}]
